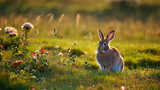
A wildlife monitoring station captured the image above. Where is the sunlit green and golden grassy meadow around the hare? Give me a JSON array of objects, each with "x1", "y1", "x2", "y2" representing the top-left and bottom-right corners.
[{"x1": 0, "y1": 13, "x2": 160, "y2": 90}]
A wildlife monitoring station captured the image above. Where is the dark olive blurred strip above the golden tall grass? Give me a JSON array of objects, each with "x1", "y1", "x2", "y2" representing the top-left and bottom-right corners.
[{"x1": 0, "y1": 0, "x2": 160, "y2": 20}]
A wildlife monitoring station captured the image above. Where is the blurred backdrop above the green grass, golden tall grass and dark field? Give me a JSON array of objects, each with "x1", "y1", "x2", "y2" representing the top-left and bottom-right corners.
[{"x1": 0, "y1": 0, "x2": 160, "y2": 42}]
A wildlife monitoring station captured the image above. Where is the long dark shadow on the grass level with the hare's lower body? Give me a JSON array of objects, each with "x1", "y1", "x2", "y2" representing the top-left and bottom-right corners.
[{"x1": 125, "y1": 59, "x2": 160, "y2": 69}]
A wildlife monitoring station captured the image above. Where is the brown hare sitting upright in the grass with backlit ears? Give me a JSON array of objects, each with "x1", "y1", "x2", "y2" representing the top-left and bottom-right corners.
[{"x1": 96, "y1": 30, "x2": 124, "y2": 72}]
